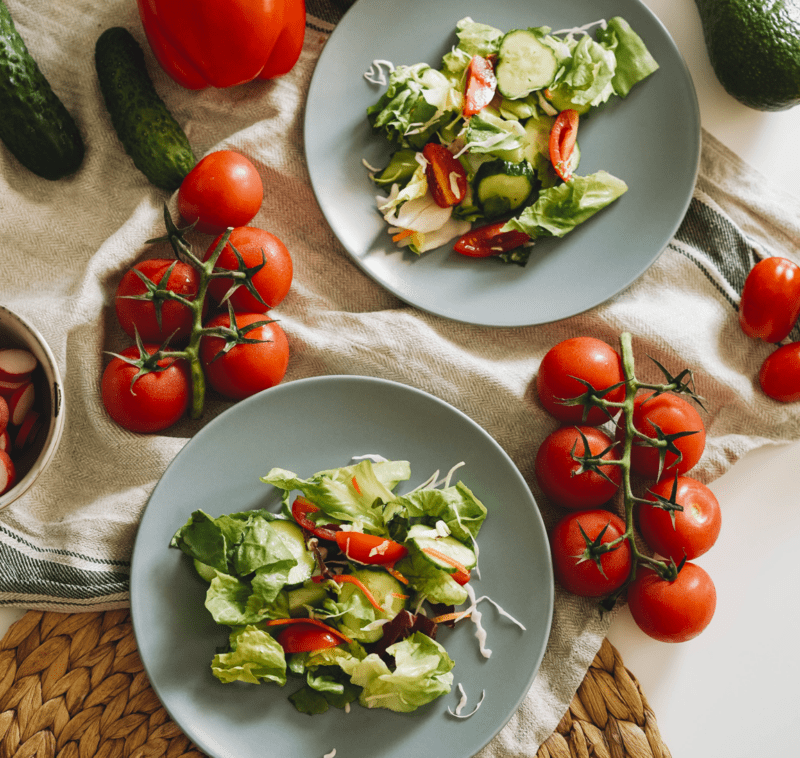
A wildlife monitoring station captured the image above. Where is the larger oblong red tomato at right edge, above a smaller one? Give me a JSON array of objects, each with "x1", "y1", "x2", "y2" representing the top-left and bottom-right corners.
[{"x1": 739, "y1": 256, "x2": 800, "y2": 342}]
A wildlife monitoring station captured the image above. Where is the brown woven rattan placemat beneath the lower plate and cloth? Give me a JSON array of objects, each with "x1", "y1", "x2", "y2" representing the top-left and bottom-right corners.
[{"x1": 0, "y1": 610, "x2": 670, "y2": 758}]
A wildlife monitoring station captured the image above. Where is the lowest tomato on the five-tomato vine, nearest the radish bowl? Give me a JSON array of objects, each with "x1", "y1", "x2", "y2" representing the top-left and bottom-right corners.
[{"x1": 100, "y1": 344, "x2": 192, "y2": 434}]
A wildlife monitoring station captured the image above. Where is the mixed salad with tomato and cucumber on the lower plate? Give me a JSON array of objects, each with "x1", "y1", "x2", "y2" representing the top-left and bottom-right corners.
[{"x1": 170, "y1": 456, "x2": 518, "y2": 714}]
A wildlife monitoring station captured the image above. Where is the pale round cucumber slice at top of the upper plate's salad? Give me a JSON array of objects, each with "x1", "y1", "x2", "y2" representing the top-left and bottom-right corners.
[{"x1": 495, "y1": 29, "x2": 558, "y2": 100}]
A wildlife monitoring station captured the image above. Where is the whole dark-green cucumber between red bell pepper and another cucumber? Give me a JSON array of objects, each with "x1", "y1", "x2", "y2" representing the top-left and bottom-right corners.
[{"x1": 95, "y1": 26, "x2": 196, "y2": 192}]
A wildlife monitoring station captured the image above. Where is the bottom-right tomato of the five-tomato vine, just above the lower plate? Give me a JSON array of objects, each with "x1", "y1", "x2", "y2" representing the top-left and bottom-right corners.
[{"x1": 200, "y1": 313, "x2": 289, "y2": 400}]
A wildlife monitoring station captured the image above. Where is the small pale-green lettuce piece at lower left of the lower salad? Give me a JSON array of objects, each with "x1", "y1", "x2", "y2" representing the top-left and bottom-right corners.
[{"x1": 211, "y1": 625, "x2": 286, "y2": 686}]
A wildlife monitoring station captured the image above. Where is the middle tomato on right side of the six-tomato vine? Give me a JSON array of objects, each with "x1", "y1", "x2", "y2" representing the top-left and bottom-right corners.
[{"x1": 638, "y1": 476, "x2": 722, "y2": 563}]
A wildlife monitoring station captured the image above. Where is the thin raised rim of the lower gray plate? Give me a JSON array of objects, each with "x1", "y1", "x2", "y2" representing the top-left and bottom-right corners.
[{"x1": 130, "y1": 374, "x2": 556, "y2": 758}]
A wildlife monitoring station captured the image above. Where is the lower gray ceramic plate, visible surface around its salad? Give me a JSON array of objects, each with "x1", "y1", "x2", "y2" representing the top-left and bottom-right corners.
[{"x1": 131, "y1": 376, "x2": 554, "y2": 758}]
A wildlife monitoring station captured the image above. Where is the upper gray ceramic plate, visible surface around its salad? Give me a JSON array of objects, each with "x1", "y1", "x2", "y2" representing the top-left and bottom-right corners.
[{"x1": 305, "y1": 0, "x2": 700, "y2": 326}]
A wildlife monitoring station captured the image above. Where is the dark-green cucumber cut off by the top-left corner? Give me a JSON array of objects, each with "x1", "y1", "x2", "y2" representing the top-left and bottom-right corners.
[{"x1": 0, "y1": 0, "x2": 84, "y2": 181}]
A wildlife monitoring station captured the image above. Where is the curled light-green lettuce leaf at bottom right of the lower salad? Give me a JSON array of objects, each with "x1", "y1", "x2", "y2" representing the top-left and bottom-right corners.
[{"x1": 339, "y1": 632, "x2": 453, "y2": 713}]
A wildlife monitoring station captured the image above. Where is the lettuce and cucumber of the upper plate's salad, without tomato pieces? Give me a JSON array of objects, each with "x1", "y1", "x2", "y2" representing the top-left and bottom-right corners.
[{"x1": 367, "y1": 17, "x2": 658, "y2": 265}]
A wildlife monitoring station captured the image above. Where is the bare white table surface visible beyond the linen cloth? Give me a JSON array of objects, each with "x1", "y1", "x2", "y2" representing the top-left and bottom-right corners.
[{"x1": 0, "y1": 0, "x2": 800, "y2": 758}]
